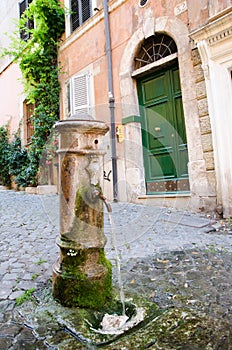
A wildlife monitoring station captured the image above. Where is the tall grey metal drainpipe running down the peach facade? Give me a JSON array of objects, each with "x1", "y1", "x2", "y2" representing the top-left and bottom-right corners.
[{"x1": 103, "y1": 0, "x2": 118, "y2": 202}]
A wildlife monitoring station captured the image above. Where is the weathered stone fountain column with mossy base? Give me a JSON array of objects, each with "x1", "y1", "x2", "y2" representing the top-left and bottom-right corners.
[{"x1": 53, "y1": 119, "x2": 112, "y2": 309}]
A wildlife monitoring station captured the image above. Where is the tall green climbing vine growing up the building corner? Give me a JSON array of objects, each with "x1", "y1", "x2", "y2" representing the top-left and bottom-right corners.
[{"x1": 1, "y1": 0, "x2": 64, "y2": 186}]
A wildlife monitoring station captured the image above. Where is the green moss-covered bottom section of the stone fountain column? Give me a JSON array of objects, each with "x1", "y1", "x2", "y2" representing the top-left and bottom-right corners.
[{"x1": 53, "y1": 249, "x2": 112, "y2": 310}]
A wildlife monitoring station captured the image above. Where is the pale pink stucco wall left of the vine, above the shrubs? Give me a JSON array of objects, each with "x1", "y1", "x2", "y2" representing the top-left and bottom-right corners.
[{"x1": 0, "y1": 64, "x2": 23, "y2": 133}]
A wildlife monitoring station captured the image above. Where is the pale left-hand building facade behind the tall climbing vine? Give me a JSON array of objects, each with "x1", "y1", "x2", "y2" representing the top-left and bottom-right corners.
[{"x1": 0, "y1": 0, "x2": 34, "y2": 145}]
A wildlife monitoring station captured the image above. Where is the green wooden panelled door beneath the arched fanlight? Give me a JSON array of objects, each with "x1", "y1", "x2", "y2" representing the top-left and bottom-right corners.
[{"x1": 138, "y1": 66, "x2": 189, "y2": 194}]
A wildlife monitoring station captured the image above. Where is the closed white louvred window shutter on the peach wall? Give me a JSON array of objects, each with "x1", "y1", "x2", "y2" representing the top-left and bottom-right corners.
[{"x1": 71, "y1": 74, "x2": 90, "y2": 114}]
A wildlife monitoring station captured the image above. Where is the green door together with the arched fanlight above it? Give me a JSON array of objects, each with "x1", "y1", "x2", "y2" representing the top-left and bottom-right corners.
[{"x1": 135, "y1": 33, "x2": 189, "y2": 194}]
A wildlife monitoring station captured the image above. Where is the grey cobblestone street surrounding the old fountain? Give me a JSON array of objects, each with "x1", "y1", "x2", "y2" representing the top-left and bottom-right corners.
[{"x1": 0, "y1": 190, "x2": 232, "y2": 350}]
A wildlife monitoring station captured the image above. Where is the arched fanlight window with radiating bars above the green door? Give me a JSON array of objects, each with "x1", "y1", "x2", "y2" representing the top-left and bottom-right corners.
[{"x1": 135, "y1": 33, "x2": 177, "y2": 69}]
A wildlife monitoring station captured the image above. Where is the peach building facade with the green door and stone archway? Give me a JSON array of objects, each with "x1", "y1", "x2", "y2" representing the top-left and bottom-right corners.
[{"x1": 59, "y1": 0, "x2": 232, "y2": 216}]
